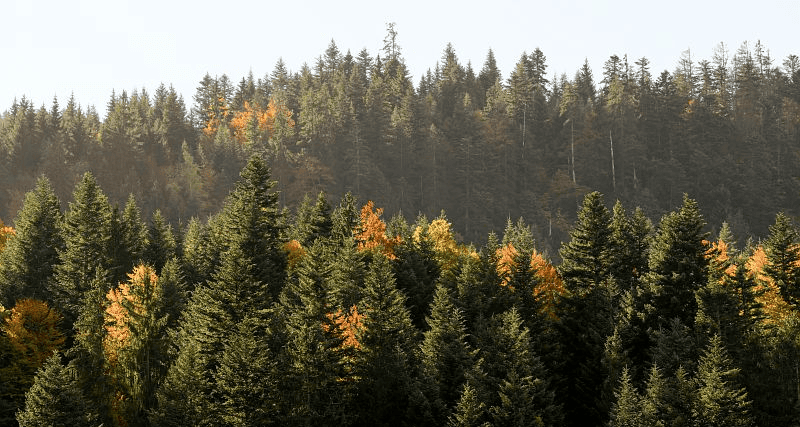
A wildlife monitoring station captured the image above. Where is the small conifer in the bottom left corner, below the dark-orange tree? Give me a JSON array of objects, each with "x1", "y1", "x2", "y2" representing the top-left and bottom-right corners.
[{"x1": 17, "y1": 353, "x2": 101, "y2": 427}]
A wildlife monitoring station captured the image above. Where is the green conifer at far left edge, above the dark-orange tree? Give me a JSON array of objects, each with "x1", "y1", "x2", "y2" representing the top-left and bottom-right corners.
[{"x1": 0, "y1": 177, "x2": 64, "y2": 307}]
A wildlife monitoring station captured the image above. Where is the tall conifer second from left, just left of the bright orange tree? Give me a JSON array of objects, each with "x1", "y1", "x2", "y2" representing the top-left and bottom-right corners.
[{"x1": 49, "y1": 172, "x2": 112, "y2": 327}]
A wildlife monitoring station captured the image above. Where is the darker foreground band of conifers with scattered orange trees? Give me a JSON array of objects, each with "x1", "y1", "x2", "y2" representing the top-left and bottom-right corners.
[{"x1": 0, "y1": 155, "x2": 800, "y2": 426}]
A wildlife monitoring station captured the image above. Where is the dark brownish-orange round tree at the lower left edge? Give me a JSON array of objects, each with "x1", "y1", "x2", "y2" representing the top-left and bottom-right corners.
[{"x1": 3, "y1": 299, "x2": 64, "y2": 370}]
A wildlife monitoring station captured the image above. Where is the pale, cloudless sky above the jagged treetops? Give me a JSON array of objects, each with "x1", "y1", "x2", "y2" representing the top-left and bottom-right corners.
[{"x1": 0, "y1": 0, "x2": 800, "y2": 117}]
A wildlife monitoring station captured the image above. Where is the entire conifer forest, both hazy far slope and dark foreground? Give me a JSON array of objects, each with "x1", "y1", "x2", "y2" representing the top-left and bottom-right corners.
[{"x1": 0, "y1": 31, "x2": 800, "y2": 427}]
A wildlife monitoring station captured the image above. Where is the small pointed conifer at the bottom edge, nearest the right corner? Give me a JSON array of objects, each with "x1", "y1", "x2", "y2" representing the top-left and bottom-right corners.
[{"x1": 692, "y1": 335, "x2": 754, "y2": 427}]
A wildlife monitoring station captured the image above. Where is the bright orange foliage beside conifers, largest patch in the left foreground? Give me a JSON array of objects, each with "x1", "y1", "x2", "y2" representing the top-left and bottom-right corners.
[{"x1": 103, "y1": 265, "x2": 159, "y2": 364}]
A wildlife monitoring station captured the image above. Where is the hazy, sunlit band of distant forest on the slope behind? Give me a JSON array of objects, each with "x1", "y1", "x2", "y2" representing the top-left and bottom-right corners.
[{"x1": 0, "y1": 35, "x2": 800, "y2": 256}]
